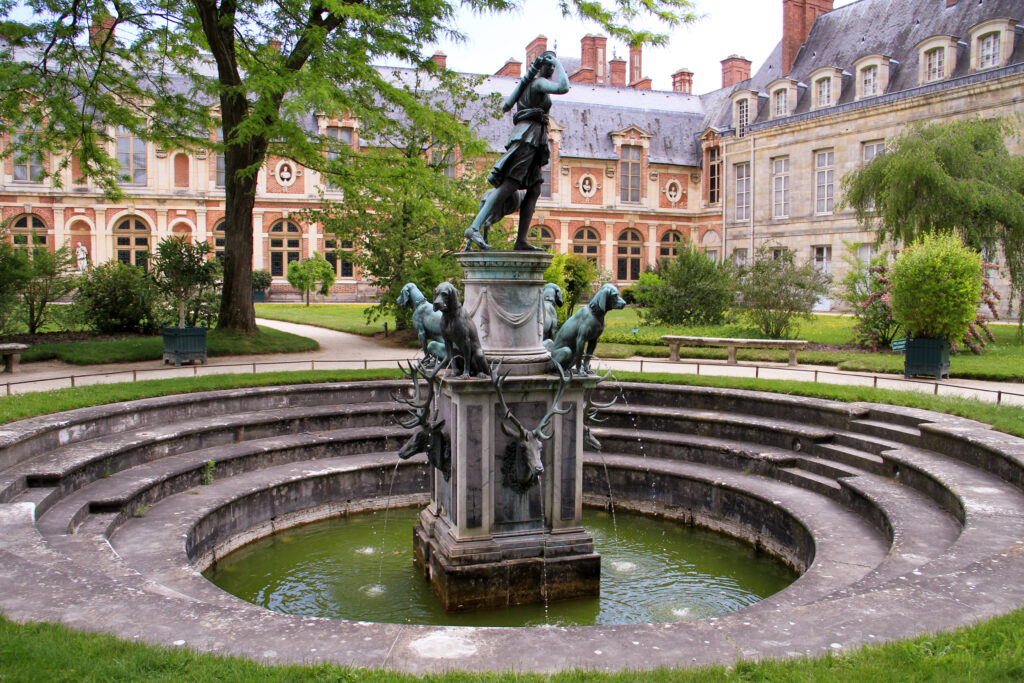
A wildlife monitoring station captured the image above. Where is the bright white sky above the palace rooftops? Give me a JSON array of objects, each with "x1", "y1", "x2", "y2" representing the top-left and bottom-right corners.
[{"x1": 434, "y1": 0, "x2": 856, "y2": 94}]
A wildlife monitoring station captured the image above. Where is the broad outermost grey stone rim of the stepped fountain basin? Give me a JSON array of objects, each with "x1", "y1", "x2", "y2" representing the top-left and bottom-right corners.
[{"x1": 0, "y1": 383, "x2": 1024, "y2": 673}]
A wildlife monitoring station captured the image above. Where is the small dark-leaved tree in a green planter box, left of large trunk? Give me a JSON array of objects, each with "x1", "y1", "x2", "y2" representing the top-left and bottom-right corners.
[{"x1": 153, "y1": 237, "x2": 220, "y2": 366}]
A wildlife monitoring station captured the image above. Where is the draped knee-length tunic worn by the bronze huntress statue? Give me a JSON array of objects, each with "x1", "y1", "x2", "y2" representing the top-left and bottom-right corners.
[{"x1": 487, "y1": 83, "x2": 551, "y2": 189}]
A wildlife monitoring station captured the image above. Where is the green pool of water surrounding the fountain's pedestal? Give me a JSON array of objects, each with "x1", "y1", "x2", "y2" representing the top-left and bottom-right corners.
[{"x1": 206, "y1": 508, "x2": 797, "y2": 627}]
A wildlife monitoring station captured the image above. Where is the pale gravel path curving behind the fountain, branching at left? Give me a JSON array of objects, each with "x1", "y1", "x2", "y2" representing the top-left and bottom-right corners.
[{"x1": 0, "y1": 318, "x2": 1024, "y2": 405}]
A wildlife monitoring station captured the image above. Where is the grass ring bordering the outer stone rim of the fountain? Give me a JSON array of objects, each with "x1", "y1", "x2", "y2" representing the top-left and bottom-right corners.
[{"x1": 0, "y1": 370, "x2": 1024, "y2": 683}]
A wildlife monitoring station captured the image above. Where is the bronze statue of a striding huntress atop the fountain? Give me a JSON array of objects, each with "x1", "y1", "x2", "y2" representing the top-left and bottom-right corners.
[{"x1": 466, "y1": 50, "x2": 569, "y2": 251}]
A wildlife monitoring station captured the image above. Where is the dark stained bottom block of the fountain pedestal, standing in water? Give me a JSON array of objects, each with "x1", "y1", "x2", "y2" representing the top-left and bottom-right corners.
[{"x1": 413, "y1": 524, "x2": 601, "y2": 611}]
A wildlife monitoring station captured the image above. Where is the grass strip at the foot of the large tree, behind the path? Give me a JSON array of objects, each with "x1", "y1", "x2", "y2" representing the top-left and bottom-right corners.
[{"x1": 22, "y1": 328, "x2": 319, "y2": 366}]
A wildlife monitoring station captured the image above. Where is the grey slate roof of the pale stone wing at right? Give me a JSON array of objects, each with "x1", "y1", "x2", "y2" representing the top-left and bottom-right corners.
[{"x1": 709, "y1": 0, "x2": 1024, "y2": 128}]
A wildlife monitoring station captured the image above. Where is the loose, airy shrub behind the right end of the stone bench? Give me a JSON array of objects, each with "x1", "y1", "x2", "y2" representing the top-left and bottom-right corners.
[{"x1": 739, "y1": 243, "x2": 829, "y2": 339}]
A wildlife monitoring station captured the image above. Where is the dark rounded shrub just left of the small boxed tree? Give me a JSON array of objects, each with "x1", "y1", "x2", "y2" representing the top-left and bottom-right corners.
[{"x1": 75, "y1": 261, "x2": 160, "y2": 334}]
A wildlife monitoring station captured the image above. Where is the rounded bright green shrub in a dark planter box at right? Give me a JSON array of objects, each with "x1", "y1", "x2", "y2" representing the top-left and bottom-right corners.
[{"x1": 890, "y1": 232, "x2": 981, "y2": 379}]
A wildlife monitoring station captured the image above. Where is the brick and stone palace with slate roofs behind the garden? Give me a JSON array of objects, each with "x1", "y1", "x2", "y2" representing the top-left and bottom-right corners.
[{"x1": 0, "y1": 0, "x2": 1024, "y2": 307}]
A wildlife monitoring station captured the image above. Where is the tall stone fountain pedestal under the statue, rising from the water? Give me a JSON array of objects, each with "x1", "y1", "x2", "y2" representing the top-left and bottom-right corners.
[{"x1": 414, "y1": 252, "x2": 601, "y2": 610}]
